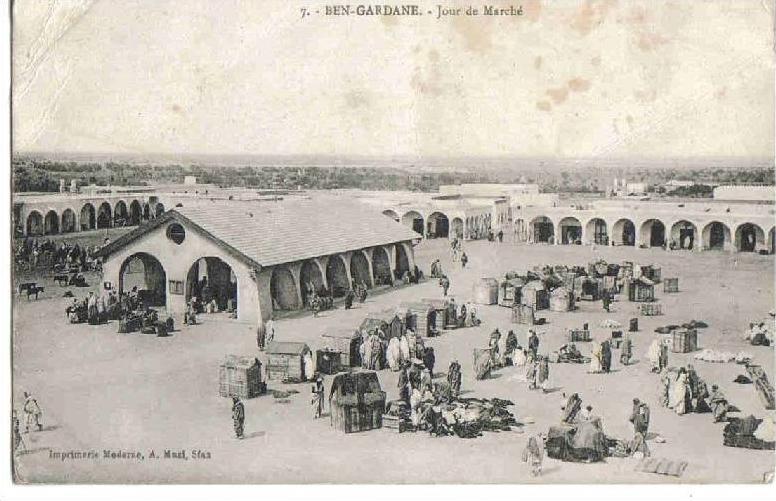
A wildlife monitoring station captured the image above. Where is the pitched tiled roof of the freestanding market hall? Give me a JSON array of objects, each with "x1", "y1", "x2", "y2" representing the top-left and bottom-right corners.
[{"x1": 104, "y1": 200, "x2": 421, "y2": 266}]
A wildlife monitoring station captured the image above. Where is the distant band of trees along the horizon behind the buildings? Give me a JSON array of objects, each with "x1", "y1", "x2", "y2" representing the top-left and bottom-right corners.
[{"x1": 12, "y1": 158, "x2": 776, "y2": 196}]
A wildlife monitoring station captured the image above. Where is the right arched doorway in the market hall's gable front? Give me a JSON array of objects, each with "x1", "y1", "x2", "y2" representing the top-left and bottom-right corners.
[{"x1": 186, "y1": 256, "x2": 239, "y2": 312}]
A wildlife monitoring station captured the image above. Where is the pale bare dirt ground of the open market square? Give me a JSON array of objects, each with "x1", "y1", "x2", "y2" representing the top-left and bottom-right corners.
[{"x1": 13, "y1": 241, "x2": 775, "y2": 483}]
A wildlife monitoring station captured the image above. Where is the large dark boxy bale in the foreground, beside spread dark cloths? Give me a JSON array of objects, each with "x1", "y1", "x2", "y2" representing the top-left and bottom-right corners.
[{"x1": 329, "y1": 371, "x2": 386, "y2": 433}]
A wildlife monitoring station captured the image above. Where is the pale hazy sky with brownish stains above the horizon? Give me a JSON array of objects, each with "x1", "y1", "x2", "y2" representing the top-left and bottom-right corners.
[{"x1": 13, "y1": 0, "x2": 774, "y2": 157}]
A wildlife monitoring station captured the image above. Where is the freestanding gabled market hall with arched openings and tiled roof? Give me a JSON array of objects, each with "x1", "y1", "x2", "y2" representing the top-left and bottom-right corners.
[{"x1": 100, "y1": 200, "x2": 421, "y2": 332}]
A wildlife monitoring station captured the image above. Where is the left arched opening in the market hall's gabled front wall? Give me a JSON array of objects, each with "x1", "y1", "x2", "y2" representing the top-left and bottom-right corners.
[{"x1": 119, "y1": 252, "x2": 167, "y2": 306}]
